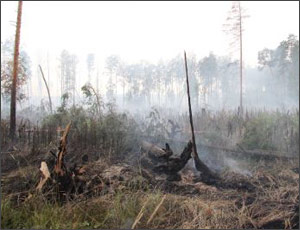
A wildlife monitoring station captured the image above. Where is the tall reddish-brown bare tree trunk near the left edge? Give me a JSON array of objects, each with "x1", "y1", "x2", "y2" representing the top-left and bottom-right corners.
[{"x1": 10, "y1": 1, "x2": 22, "y2": 140}]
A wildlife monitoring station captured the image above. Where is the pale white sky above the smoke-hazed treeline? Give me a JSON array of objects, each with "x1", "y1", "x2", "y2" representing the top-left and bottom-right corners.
[{"x1": 1, "y1": 1, "x2": 299, "y2": 99}]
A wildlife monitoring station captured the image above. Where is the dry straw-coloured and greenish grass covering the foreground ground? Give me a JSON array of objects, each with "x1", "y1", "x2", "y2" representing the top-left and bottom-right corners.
[{"x1": 1, "y1": 155, "x2": 299, "y2": 229}]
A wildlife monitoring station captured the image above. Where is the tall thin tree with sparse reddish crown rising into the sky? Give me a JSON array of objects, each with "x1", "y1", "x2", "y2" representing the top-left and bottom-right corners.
[{"x1": 224, "y1": 1, "x2": 248, "y2": 114}]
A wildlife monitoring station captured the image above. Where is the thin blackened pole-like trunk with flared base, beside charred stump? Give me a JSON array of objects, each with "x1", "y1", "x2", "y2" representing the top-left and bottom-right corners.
[{"x1": 184, "y1": 51, "x2": 212, "y2": 176}]
